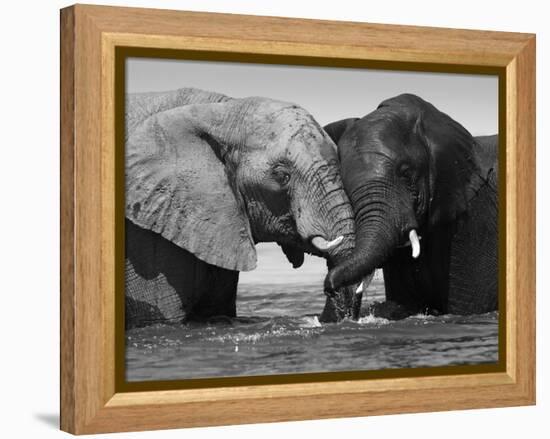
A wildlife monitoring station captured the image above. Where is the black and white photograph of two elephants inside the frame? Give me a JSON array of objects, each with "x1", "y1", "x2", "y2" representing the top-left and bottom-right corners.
[{"x1": 124, "y1": 57, "x2": 499, "y2": 382}]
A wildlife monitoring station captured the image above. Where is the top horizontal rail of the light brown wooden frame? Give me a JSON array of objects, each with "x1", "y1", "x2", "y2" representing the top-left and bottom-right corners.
[{"x1": 82, "y1": 5, "x2": 527, "y2": 66}]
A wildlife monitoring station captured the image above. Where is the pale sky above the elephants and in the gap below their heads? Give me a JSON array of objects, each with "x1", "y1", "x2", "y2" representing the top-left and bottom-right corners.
[{"x1": 126, "y1": 58, "x2": 498, "y2": 284}]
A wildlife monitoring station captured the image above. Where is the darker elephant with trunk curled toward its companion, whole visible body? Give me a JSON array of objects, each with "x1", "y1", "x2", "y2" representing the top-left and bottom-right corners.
[{"x1": 324, "y1": 94, "x2": 498, "y2": 318}]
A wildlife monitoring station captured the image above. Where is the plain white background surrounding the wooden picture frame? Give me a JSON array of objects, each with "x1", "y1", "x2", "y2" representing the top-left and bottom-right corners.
[{"x1": 0, "y1": 0, "x2": 550, "y2": 439}]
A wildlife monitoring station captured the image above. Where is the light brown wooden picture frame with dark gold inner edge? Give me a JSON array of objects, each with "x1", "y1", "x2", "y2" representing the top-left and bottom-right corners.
[{"x1": 61, "y1": 5, "x2": 535, "y2": 434}]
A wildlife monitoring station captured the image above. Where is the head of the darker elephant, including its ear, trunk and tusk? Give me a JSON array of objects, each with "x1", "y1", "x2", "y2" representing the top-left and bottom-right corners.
[{"x1": 325, "y1": 94, "x2": 490, "y2": 298}]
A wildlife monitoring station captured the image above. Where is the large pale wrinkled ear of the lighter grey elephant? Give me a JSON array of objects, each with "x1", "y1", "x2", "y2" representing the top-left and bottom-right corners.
[{"x1": 126, "y1": 104, "x2": 256, "y2": 271}]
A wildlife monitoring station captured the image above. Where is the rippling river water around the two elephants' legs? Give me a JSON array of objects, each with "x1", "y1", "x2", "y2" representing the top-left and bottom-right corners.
[{"x1": 126, "y1": 258, "x2": 498, "y2": 381}]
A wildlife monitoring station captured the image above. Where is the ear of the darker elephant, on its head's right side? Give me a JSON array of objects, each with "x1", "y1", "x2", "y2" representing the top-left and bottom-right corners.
[{"x1": 381, "y1": 94, "x2": 483, "y2": 224}]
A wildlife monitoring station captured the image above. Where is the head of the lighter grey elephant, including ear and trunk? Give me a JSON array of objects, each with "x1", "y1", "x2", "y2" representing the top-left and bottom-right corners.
[{"x1": 126, "y1": 89, "x2": 354, "y2": 282}]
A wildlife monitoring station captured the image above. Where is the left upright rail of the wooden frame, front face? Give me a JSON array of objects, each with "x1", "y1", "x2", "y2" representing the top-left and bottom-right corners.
[{"x1": 74, "y1": 4, "x2": 103, "y2": 431}]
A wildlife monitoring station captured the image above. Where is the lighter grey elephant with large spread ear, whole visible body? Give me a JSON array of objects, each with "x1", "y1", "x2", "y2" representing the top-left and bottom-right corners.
[{"x1": 125, "y1": 88, "x2": 355, "y2": 328}]
